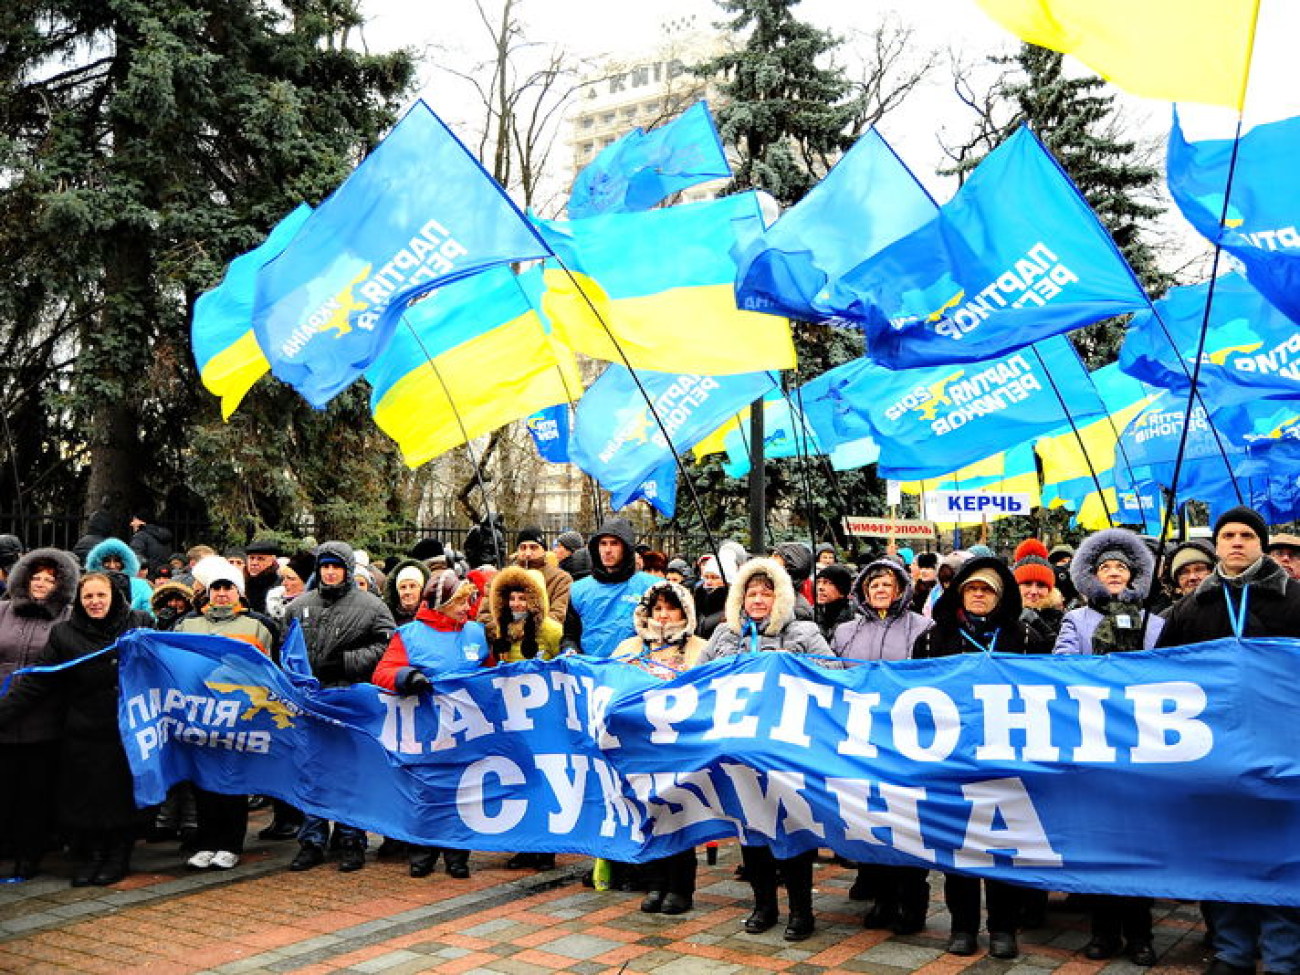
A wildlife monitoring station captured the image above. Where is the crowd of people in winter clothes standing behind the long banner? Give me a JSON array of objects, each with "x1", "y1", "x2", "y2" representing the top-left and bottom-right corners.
[{"x1": 0, "y1": 507, "x2": 1300, "y2": 975}]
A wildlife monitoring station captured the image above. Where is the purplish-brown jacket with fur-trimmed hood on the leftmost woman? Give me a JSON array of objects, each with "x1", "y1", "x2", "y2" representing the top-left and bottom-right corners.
[{"x1": 0, "y1": 549, "x2": 81, "y2": 745}]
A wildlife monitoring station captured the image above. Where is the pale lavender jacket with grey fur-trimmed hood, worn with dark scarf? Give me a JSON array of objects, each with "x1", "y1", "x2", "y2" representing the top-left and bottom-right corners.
[{"x1": 1052, "y1": 528, "x2": 1165, "y2": 654}]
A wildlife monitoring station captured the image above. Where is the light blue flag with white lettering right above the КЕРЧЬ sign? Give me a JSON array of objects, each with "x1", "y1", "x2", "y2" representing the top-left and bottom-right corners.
[{"x1": 839, "y1": 335, "x2": 1105, "y2": 481}]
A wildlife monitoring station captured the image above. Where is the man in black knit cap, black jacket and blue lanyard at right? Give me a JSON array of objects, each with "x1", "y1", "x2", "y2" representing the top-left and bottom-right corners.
[{"x1": 1157, "y1": 506, "x2": 1300, "y2": 975}]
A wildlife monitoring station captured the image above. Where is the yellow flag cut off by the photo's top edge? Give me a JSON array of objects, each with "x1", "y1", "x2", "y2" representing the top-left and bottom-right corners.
[{"x1": 975, "y1": 0, "x2": 1260, "y2": 111}]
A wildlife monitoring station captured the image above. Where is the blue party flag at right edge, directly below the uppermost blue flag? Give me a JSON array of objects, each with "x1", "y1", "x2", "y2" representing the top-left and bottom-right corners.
[{"x1": 1119, "y1": 273, "x2": 1300, "y2": 413}]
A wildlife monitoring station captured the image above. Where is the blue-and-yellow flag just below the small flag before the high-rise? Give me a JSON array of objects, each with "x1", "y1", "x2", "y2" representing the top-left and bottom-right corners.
[{"x1": 538, "y1": 192, "x2": 794, "y2": 376}]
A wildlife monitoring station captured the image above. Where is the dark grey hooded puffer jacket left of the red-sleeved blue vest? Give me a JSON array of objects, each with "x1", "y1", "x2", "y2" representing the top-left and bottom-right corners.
[{"x1": 285, "y1": 542, "x2": 397, "y2": 686}]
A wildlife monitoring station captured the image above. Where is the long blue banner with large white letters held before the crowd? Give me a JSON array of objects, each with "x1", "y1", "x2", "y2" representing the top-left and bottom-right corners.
[{"x1": 118, "y1": 631, "x2": 1300, "y2": 905}]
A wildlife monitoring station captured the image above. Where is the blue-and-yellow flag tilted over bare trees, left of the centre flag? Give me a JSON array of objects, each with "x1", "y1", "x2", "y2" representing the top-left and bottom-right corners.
[{"x1": 365, "y1": 265, "x2": 582, "y2": 467}]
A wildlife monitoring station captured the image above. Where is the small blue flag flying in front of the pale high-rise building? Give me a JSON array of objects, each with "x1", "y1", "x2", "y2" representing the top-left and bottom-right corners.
[{"x1": 568, "y1": 100, "x2": 731, "y2": 220}]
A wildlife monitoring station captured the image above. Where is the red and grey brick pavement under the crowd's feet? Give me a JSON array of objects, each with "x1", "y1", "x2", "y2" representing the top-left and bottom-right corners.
[{"x1": 0, "y1": 814, "x2": 1206, "y2": 975}]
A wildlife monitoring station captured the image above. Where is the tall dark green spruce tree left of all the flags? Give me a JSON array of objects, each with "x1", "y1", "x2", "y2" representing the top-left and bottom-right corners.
[{"x1": 0, "y1": 0, "x2": 412, "y2": 543}]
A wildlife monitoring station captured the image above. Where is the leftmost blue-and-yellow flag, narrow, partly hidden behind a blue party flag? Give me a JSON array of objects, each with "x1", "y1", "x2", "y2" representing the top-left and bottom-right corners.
[{"x1": 190, "y1": 203, "x2": 312, "y2": 420}]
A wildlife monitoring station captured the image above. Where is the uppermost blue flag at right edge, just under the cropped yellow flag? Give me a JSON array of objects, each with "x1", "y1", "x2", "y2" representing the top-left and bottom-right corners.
[{"x1": 1169, "y1": 112, "x2": 1300, "y2": 322}]
